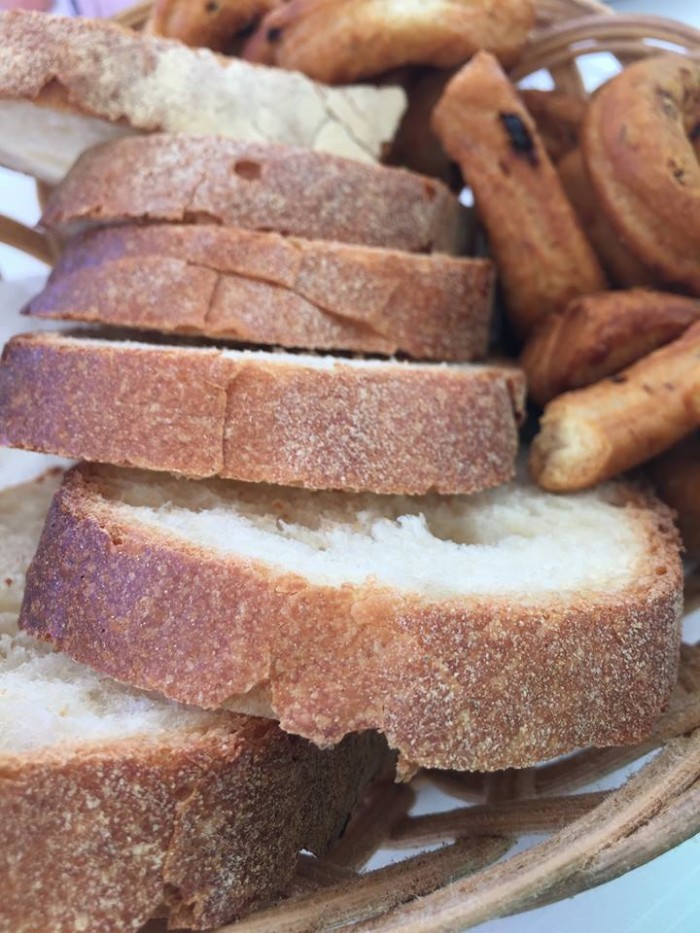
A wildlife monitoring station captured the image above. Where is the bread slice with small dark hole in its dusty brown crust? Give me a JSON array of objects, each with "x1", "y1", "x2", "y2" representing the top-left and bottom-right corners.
[{"x1": 42, "y1": 135, "x2": 466, "y2": 253}]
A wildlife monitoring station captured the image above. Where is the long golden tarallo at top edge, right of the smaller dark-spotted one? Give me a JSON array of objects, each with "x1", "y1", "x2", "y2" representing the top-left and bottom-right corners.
[{"x1": 244, "y1": 0, "x2": 534, "y2": 84}]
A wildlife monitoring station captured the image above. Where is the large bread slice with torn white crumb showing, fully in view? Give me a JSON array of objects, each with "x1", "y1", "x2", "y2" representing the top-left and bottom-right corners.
[{"x1": 22, "y1": 466, "x2": 682, "y2": 770}]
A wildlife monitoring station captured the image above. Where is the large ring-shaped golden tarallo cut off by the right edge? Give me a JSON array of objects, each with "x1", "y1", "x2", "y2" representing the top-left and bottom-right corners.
[{"x1": 582, "y1": 55, "x2": 700, "y2": 295}]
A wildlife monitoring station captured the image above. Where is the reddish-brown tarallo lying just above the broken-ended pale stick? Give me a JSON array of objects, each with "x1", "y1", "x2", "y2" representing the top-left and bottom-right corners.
[{"x1": 520, "y1": 288, "x2": 700, "y2": 405}]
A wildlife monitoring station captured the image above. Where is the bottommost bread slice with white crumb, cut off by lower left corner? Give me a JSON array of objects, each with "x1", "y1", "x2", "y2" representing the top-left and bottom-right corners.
[{"x1": 0, "y1": 477, "x2": 387, "y2": 933}]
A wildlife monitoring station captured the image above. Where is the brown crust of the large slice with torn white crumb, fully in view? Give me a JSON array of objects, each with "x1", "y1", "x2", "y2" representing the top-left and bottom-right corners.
[{"x1": 21, "y1": 466, "x2": 682, "y2": 770}]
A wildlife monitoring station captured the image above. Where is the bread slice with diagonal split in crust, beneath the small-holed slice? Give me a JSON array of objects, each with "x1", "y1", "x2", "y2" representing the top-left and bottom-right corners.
[{"x1": 27, "y1": 224, "x2": 493, "y2": 361}]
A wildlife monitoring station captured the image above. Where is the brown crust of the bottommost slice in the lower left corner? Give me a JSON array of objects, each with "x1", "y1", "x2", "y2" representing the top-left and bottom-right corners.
[{"x1": 0, "y1": 715, "x2": 385, "y2": 933}]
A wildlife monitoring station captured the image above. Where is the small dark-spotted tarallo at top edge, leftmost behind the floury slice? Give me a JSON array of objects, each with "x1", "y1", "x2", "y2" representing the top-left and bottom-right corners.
[{"x1": 146, "y1": 0, "x2": 282, "y2": 52}]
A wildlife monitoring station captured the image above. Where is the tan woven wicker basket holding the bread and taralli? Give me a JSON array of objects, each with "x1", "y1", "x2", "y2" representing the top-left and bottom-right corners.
[{"x1": 0, "y1": 0, "x2": 700, "y2": 933}]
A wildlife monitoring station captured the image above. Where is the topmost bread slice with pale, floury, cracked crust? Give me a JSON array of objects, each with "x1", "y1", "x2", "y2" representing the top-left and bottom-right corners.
[{"x1": 0, "y1": 11, "x2": 405, "y2": 184}]
